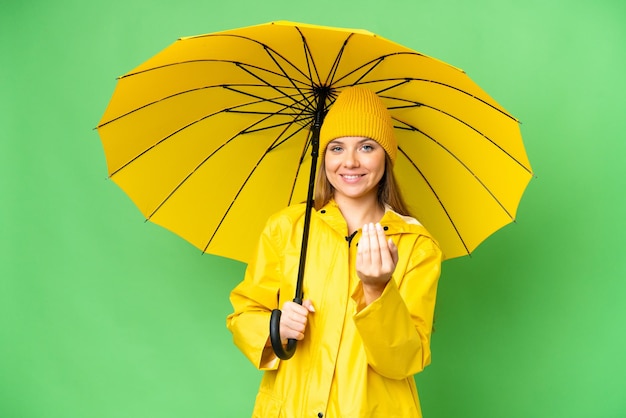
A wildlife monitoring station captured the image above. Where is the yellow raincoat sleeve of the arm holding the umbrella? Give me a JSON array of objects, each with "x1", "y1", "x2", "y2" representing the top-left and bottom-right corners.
[{"x1": 226, "y1": 217, "x2": 281, "y2": 370}]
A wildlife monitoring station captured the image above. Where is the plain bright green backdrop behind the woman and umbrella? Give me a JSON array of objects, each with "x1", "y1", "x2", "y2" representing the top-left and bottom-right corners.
[{"x1": 0, "y1": 0, "x2": 626, "y2": 418}]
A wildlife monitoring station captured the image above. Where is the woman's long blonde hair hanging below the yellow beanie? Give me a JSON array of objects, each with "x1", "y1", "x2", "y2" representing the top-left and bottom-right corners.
[{"x1": 314, "y1": 150, "x2": 413, "y2": 216}]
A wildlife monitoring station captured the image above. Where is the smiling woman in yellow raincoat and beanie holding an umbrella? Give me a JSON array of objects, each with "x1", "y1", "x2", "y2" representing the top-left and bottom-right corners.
[{"x1": 227, "y1": 87, "x2": 441, "y2": 418}]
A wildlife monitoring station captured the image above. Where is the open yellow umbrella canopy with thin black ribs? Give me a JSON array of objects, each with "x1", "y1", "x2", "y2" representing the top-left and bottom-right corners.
[{"x1": 97, "y1": 22, "x2": 532, "y2": 262}]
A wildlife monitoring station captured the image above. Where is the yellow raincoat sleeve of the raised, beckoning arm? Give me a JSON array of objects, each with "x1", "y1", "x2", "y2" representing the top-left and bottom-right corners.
[{"x1": 353, "y1": 236, "x2": 442, "y2": 379}]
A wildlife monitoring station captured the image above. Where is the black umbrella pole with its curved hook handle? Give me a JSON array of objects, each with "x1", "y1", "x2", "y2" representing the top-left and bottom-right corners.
[{"x1": 270, "y1": 87, "x2": 329, "y2": 360}]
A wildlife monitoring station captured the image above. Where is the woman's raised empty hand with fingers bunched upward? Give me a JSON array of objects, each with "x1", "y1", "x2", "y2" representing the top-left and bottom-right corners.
[{"x1": 356, "y1": 223, "x2": 398, "y2": 304}]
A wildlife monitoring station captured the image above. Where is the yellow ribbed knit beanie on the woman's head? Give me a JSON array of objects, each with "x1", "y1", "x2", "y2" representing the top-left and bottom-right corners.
[{"x1": 320, "y1": 86, "x2": 398, "y2": 162}]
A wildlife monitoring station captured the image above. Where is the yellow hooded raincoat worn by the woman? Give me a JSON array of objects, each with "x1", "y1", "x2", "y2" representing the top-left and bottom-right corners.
[{"x1": 227, "y1": 201, "x2": 441, "y2": 418}]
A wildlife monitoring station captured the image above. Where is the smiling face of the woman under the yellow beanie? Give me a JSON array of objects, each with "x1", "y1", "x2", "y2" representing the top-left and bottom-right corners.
[{"x1": 324, "y1": 136, "x2": 385, "y2": 200}]
